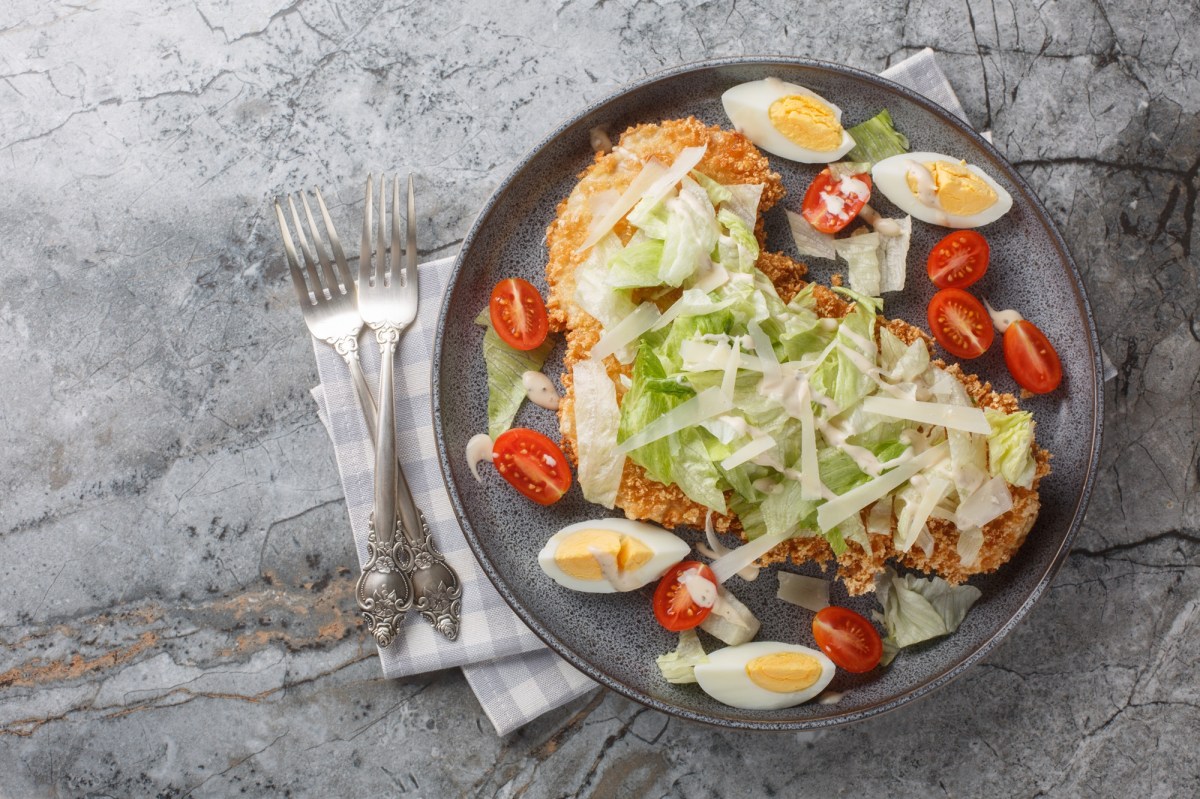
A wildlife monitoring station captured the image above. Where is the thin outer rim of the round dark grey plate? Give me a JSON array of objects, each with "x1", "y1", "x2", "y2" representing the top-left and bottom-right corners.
[{"x1": 430, "y1": 55, "x2": 1104, "y2": 732}]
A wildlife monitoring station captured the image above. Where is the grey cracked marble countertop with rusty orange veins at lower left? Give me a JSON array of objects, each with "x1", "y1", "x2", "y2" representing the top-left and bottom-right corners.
[{"x1": 0, "y1": 0, "x2": 1200, "y2": 797}]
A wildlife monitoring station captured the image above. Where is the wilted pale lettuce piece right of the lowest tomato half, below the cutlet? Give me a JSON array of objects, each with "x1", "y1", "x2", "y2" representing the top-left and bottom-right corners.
[{"x1": 875, "y1": 566, "x2": 982, "y2": 666}]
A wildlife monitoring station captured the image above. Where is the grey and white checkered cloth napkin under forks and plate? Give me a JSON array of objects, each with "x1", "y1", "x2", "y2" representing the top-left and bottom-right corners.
[{"x1": 304, "y1": 49, "x2": 1065, "y2": 735}]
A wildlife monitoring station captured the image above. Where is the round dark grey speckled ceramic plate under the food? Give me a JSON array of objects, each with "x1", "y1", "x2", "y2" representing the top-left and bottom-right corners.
[{"x1": 432, "y1": 58, "x2": 1102, "y2": 729}]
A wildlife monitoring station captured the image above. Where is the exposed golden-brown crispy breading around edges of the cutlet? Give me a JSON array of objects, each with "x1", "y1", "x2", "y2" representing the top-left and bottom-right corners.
[{"x1": 546, "y1": 119, "x2": 1050, "y2": 594}]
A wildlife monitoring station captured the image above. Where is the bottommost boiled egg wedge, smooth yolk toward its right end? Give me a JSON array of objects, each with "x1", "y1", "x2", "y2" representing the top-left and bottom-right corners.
[{"x1": 696, "y1": 641, "x2": 835, "y2": 710}]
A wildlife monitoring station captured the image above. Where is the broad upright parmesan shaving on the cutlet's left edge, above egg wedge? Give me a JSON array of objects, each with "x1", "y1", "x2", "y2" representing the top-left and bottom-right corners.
[{"x1": 572, "y1": 359, "x2": 625, "y2": 509}]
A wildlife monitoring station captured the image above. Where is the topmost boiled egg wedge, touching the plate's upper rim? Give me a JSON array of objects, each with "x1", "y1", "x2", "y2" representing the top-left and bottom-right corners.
[{"x1": 721, "y1": 78, "x2": 854, "y2": 163}]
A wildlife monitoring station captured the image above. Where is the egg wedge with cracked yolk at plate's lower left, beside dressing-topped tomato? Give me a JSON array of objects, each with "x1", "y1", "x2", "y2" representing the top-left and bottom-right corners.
[{"x1": 538, "y1": 518, "x2": 691, "y2": 594}]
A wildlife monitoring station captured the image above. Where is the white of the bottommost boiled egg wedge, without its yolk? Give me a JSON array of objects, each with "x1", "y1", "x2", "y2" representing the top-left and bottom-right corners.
[{"x1": 695, "y1": 641, "x2": 836, "y2": 710}]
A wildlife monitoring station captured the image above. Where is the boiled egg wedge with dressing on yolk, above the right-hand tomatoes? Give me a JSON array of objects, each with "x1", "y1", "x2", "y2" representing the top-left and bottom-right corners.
[{"x1": 871, "y1": 152, "x2": 1013, "y2": 228}]
